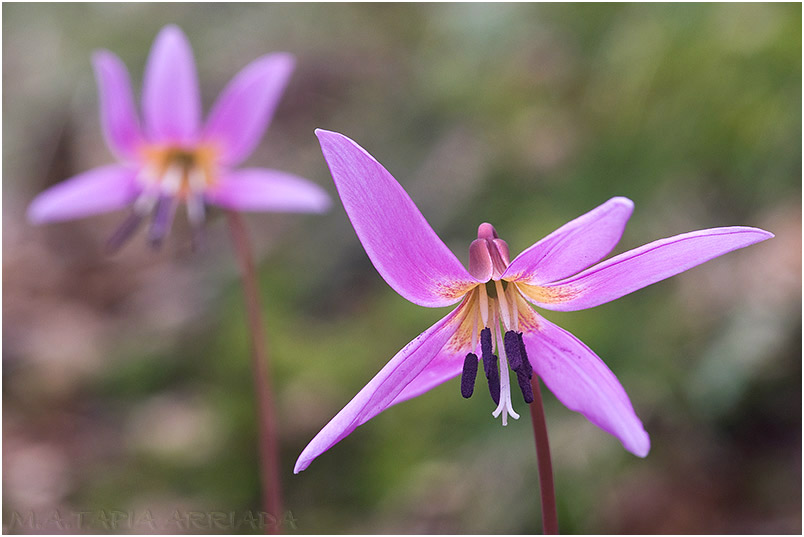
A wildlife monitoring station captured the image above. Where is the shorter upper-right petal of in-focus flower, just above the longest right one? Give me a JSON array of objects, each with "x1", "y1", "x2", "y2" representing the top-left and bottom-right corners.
[{"x1": 502, "y1": 197, "x2": 634, "y2": 285}]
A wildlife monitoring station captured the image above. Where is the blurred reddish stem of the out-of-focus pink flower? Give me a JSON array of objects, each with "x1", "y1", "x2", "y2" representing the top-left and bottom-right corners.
[{"x1": 226, "y1": 211, "x2": 283, "y2": 534}]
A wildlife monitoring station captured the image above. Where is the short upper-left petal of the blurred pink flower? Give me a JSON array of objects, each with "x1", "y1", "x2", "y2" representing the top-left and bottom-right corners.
[{"x1": 92, "y1": 50, "x2": 142, "y2": 160}]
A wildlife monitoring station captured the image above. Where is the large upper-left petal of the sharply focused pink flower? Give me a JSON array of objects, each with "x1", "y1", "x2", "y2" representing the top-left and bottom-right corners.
[{"x1": 316, "y1": 129, "x2": 479, "y2": 307}]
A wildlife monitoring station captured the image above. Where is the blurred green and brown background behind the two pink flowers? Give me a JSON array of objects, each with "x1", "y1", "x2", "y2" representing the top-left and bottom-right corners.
[{"x1": 2, "y1": 4, "x2": 802, "y2": 533}]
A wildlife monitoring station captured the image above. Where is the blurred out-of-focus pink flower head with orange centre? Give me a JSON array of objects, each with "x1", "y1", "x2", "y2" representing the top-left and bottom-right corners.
[{"x1": 28, "y1": 26, "x2": 330, "y2": 248}]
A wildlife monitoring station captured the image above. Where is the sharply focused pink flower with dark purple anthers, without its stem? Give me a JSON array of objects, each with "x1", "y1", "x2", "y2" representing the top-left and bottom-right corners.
[{"x1": 294, "y1": 130, "x2": 773, "y2": 473}]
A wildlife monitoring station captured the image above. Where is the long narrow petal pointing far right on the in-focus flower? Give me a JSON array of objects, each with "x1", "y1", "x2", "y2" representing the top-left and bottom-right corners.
[{"x1": 520, "y1": 227, "x2": 773, "y2": 311}]
